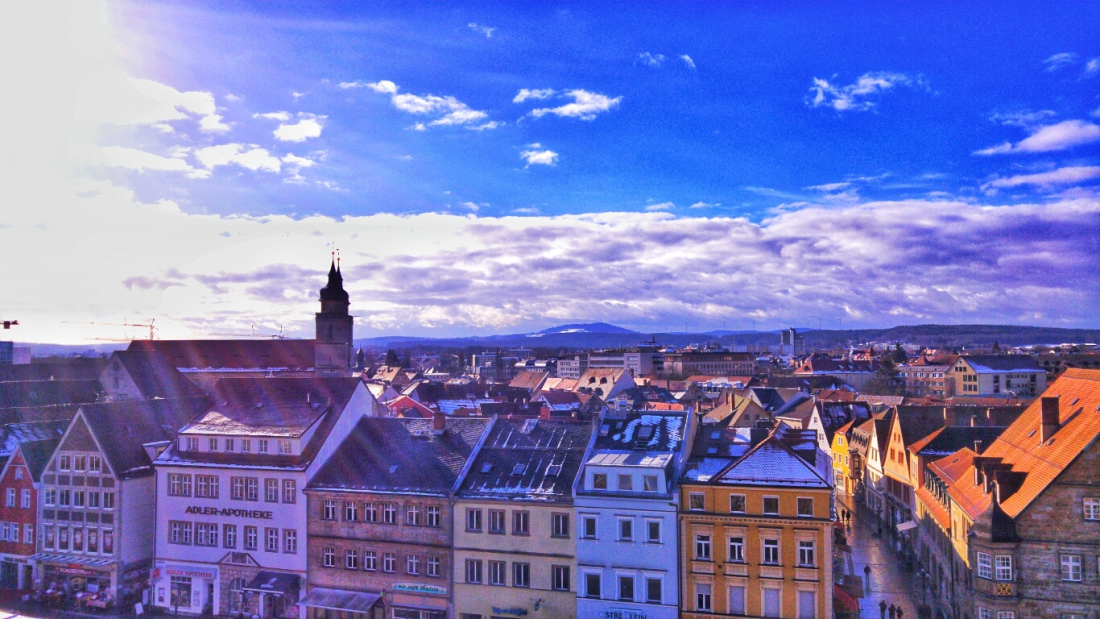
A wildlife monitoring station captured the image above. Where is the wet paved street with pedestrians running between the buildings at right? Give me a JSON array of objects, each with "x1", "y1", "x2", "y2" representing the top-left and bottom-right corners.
[{"x1": 838, "y1": 500, "x2": 922, "y2": 619}]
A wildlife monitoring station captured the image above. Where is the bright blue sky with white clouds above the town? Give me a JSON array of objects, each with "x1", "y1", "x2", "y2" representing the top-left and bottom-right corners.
[{"x1": 0, "y1": 2, "x2": 1100, "y2": 340}]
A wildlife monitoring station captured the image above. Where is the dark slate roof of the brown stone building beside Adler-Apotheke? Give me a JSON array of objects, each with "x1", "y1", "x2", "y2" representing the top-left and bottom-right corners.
[{"x1": 309, "y1": 418, "x2": 492, "y2": 494}]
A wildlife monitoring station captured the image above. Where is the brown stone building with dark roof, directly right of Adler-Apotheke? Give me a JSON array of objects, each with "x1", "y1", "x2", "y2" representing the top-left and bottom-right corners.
[{"x1": 303, "y1": 413, "x2": 493, "y2": 619}]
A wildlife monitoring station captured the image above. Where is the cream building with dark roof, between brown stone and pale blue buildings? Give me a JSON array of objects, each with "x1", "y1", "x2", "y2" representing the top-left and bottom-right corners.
[{"x1": 453, "y1": 419, "x2": 593, "y2": 619}]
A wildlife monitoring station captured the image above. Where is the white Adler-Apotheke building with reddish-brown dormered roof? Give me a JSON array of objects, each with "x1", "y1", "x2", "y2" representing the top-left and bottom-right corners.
[{"x1": 146, "y1": 378, "x2": 380, "y2": 619}]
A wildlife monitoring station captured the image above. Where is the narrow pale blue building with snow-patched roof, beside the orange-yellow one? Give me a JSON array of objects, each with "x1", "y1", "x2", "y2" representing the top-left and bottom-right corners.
[{"x1": 574, "y1": 412, "x2": 694, "y2": 619}]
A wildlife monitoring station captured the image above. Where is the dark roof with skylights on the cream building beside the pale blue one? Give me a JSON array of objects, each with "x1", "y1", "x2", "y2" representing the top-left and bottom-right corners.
[{"x1": 458, "y1": 419, "x2": 593, "y2": 502}]
